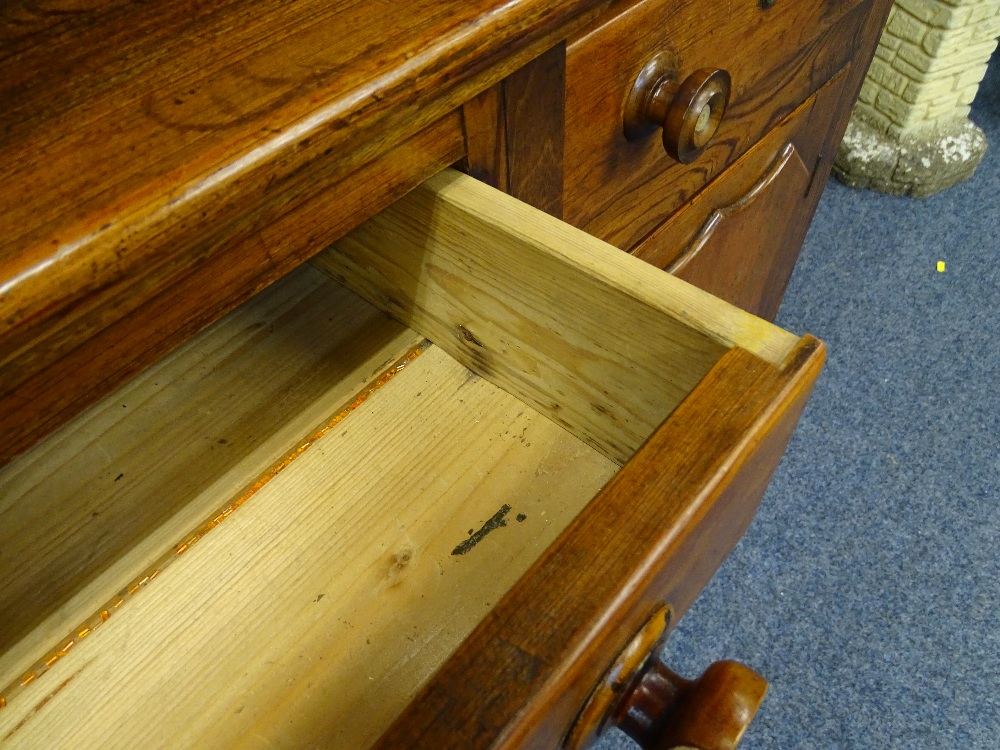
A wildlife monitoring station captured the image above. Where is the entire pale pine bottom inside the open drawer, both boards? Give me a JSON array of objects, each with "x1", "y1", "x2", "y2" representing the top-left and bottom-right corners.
[{"x1": 0, "y1": 267, "x2": 618, "y2": 749}]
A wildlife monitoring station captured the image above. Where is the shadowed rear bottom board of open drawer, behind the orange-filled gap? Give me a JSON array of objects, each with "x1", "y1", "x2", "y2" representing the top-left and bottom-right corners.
[{"x1": 0, "y1": 267, "x2": 422, "y2": 691}]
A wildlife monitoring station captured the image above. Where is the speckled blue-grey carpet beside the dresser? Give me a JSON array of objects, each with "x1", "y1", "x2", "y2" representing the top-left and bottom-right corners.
[{"x1": 601, "y1": 61, "x2": 1000, "y2": 750}]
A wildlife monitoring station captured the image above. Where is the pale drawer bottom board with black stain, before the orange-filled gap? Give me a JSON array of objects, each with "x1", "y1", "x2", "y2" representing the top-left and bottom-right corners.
[{"x1": 0, "y1": 298, "x2": 617, "y2": 748}]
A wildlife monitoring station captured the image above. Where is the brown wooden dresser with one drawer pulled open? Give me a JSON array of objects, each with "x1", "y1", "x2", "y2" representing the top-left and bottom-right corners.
[{"x1": 0, "y1": 0, "x2": 890, "y2": 750}]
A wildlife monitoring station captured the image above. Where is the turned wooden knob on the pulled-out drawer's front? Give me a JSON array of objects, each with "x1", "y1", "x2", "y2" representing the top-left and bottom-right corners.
[{"x1": 564, "y1": 607, "x2": 767, "y2": 750}]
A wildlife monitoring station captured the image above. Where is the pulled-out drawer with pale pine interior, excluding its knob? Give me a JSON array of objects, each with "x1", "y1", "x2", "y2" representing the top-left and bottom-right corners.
[{"x1": 0, "y1": 172, "x2": 823, "y2": 749}]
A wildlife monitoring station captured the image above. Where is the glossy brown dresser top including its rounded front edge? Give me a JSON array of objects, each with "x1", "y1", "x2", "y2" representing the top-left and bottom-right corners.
[{"x1": 0, "y1": 0, "x2": 598, "y2": 364}]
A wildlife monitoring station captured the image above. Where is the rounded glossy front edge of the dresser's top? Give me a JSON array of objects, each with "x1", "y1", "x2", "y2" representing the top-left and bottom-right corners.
[{"x1": 0, "y1": 0, "x2": 608, "y2": 424}]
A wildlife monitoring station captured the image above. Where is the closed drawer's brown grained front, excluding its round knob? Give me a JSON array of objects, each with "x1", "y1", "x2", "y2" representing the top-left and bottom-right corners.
[{"x1": 563, "y1": 0, "x2": 870, "y2": 249}]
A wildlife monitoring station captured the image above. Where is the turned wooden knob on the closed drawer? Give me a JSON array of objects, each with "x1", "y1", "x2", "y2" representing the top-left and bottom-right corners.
[{"x1": 624, "y1": 52, "x2": 732, "y2": 164}]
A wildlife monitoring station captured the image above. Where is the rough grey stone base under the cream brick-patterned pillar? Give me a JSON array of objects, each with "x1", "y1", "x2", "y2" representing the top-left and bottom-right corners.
[{"x1": 833, "y1": 118, "x2": 986, "y2": 198}]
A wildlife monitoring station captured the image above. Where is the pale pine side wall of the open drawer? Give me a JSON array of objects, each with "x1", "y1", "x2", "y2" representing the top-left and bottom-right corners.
[{"x1": 313, "y1": 171, "x2": 797, "y2": 463}]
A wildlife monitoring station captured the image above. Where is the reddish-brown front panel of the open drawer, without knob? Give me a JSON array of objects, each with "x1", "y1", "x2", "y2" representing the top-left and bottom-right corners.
[{"x1": 377, "y1": 337, "x2": 823, "y2": 750}]
